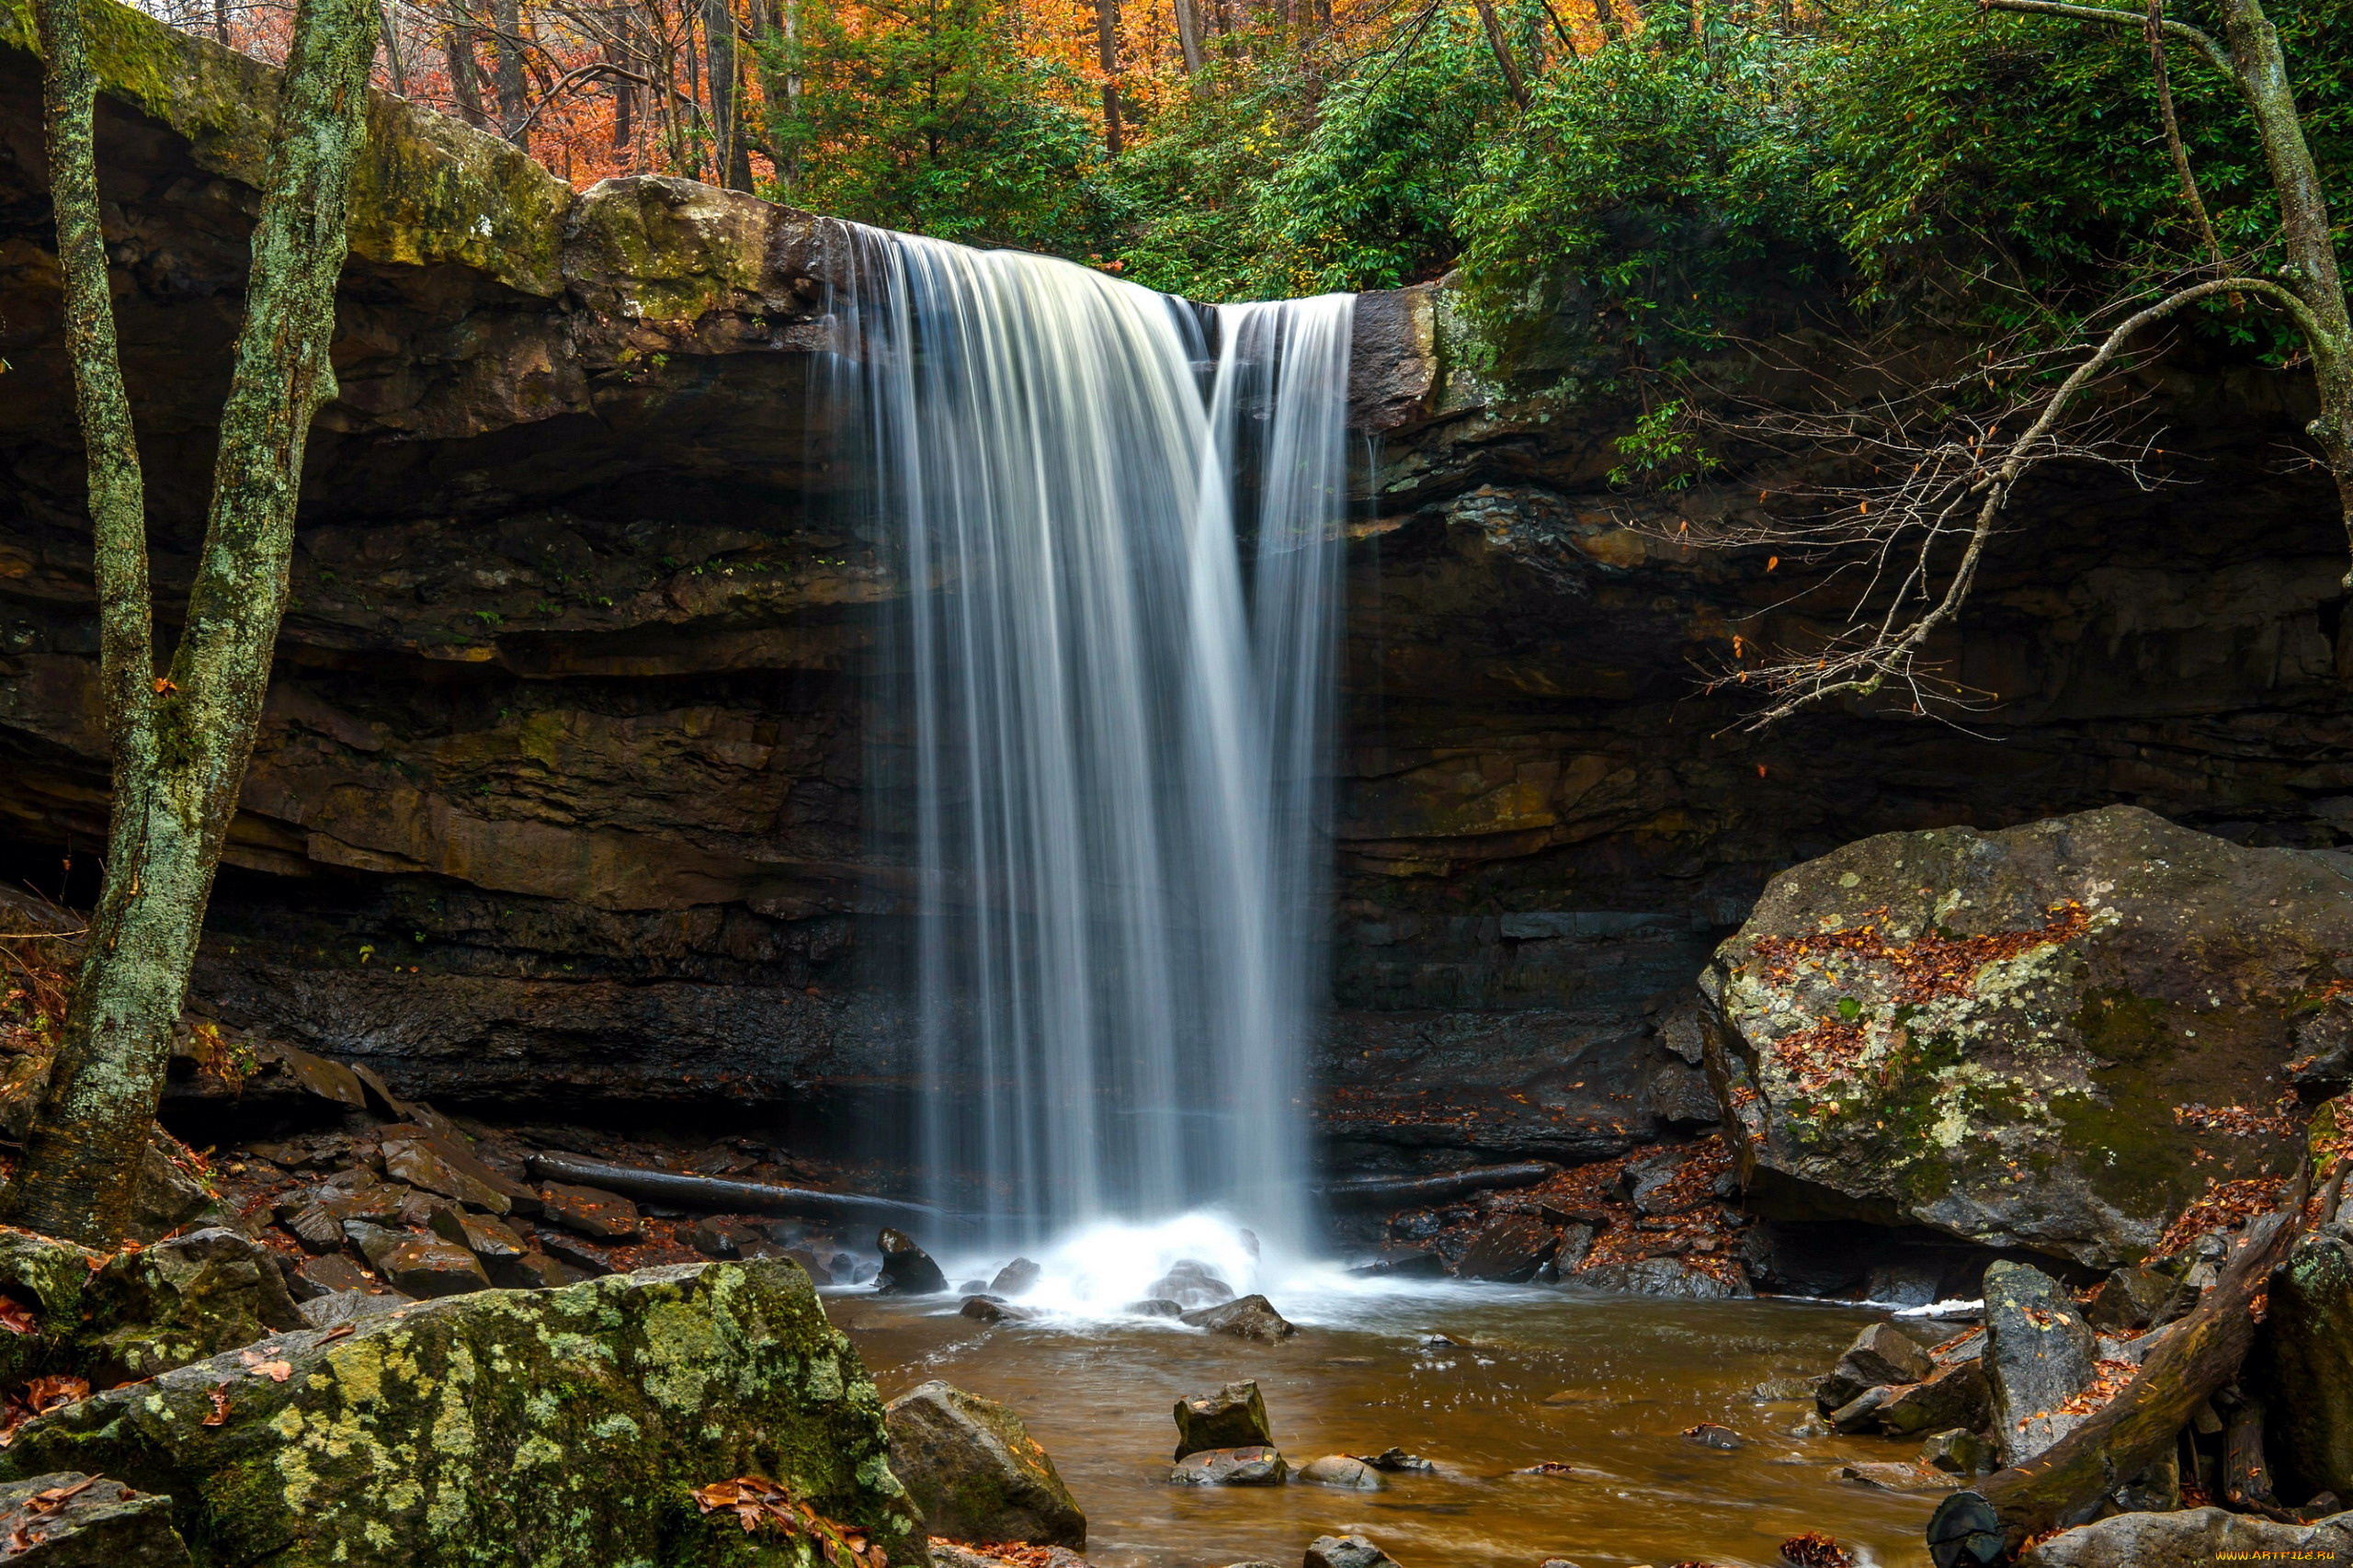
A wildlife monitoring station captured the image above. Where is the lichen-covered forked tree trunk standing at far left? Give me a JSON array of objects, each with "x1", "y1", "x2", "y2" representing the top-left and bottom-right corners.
[{"x1": 9, "y1": 0, "x2": 379, "y2": 1245}]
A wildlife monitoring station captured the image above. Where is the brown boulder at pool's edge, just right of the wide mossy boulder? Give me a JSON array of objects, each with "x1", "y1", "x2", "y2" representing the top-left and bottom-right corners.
[{"x1": 885, "y1": 1382, "x2": 1087, "y2": 1550}]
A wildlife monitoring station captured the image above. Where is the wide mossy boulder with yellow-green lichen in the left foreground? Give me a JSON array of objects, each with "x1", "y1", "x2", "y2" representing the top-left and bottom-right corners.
[{"x1": 0, "y1": 1259, "x2": 929, "y2": 1568}]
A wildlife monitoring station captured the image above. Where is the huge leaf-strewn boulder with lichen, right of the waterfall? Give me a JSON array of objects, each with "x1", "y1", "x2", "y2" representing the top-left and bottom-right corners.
[{"x1": 1701, "y1": 805, "x2": 2353, "y2": 1267}]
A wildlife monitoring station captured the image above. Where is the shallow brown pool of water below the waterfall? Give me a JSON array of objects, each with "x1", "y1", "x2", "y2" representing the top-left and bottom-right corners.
[{"x1": 828, "y1": 1286, "x2": 1934, "y2": 1568}]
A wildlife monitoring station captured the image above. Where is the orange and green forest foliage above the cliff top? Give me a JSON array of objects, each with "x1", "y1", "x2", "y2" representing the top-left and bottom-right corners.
[{"x1": 137, "y1": 0, "x2": 2353, "y2": 351}]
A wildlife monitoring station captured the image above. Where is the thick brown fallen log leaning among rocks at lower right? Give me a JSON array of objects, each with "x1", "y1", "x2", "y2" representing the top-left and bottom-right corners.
[{"x1": 1927, "y1": 1163, "x2": 2346, "y2": 1568}]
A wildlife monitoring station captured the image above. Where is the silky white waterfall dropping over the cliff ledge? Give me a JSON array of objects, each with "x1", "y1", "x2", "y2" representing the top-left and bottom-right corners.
[{"x1": 837, "y1": 231, "x2": 1353, "y2": 1245}]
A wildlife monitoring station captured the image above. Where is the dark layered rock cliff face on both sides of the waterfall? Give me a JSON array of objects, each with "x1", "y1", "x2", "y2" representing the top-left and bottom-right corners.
[{"x1": 0, "y1": 0, "x2": 2353, "y2": 1168}]
